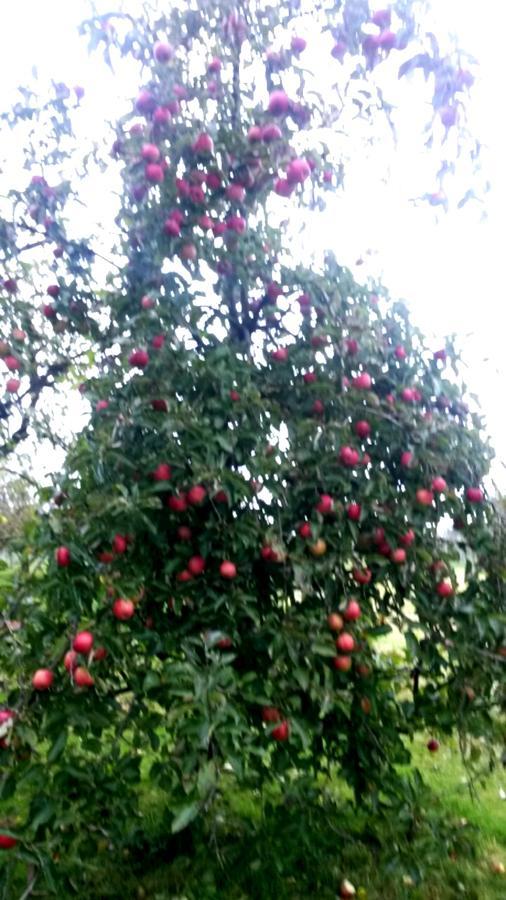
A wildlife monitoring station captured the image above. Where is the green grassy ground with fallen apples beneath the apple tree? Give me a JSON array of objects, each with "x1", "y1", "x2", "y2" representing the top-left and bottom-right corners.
[{"x1": 50, "y1": 740, "x2": 498, "y2": 900}]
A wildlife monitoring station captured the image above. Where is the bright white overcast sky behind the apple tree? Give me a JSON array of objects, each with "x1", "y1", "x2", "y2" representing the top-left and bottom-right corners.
[{"x1": 0, "y1": 0, "x2": 506, "y2": 490}]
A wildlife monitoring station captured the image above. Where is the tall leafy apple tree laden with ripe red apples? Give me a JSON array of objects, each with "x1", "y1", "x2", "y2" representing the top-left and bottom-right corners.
[{"x1": 0, "y1": 0, "x2": 506, "y2": 891}]
